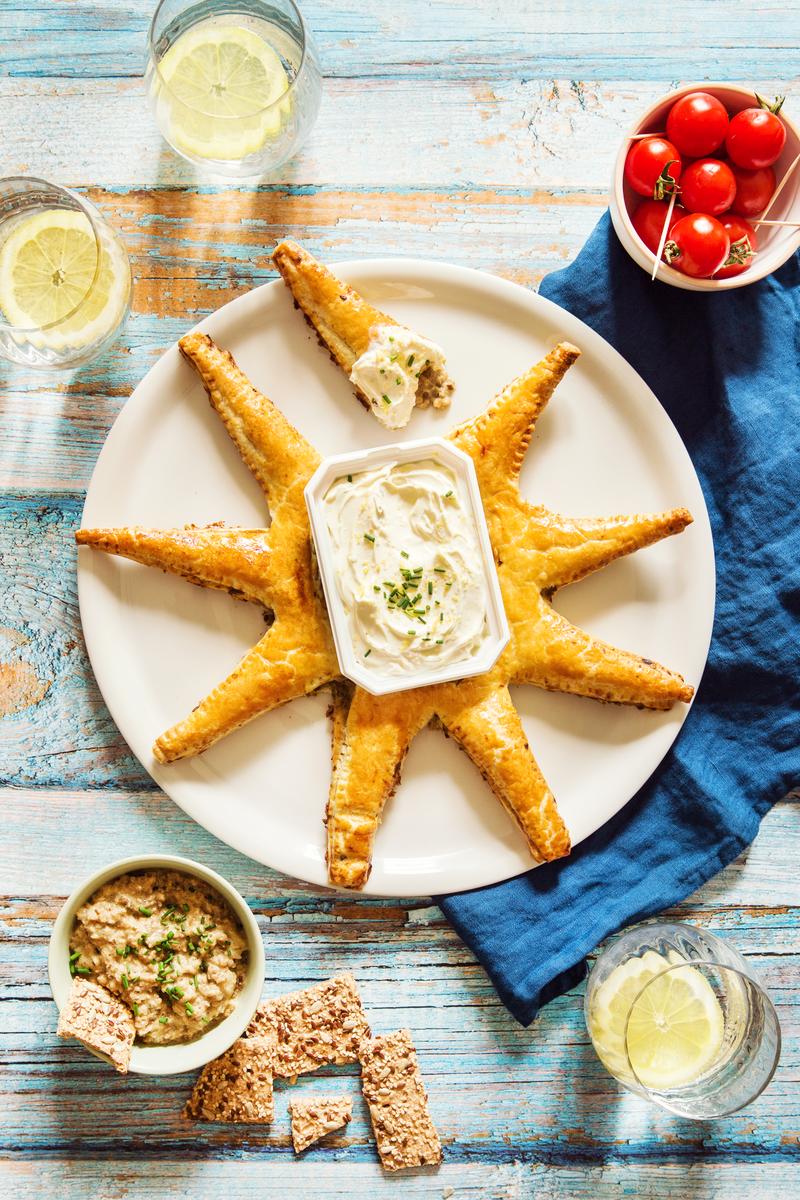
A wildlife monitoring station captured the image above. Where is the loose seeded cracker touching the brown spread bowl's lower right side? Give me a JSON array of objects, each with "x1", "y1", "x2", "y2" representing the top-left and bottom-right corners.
[{"x1": 184, "y1": 1037, "x2": 275, "y2": 1124}]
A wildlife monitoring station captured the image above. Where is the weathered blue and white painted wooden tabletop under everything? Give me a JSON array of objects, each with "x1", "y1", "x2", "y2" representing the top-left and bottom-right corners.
[{"x1": 0, "y1": 0, "x2": 800, "y2": 1200}]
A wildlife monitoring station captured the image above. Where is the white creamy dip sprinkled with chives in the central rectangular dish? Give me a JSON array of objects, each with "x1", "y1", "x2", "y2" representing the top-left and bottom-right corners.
[{"x1": 323, "y1": 457, "x2": 488, "y2": 677}]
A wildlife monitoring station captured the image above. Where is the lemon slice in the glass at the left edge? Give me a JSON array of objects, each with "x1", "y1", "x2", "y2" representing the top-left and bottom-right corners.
[{"x1": 0, "y1": 209, "x2": 130, "y2": 349}]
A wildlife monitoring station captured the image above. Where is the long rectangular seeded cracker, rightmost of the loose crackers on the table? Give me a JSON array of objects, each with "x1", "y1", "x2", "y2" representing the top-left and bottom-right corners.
[{"x1": 359, "y1": 1030, "x2": 441, "y2": 1171}]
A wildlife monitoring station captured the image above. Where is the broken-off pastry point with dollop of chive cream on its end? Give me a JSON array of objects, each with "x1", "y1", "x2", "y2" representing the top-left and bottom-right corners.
[{"x1": 272, "y1": 241, "x2": 455, "y2": 430}]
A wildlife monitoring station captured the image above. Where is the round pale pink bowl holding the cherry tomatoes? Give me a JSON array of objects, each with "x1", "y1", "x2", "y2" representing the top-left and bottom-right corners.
[{"x1": 609, "y1": 83, "x2": 800, "y2": 292}]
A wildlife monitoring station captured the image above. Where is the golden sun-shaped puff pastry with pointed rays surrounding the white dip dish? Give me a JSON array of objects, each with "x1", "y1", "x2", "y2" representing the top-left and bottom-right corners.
[{"x1": 76, "y1": 334, "x2": 693, "y2": 888}]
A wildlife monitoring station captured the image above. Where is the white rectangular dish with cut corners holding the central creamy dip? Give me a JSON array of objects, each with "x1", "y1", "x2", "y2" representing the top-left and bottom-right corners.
[{"x1": 306, "y1": 438, "x2": 510, "y2": 696}]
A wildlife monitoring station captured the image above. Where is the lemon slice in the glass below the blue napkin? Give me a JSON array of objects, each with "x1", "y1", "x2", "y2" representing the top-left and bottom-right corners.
[{"x1": 589, "y1": 950, "x2": 724, "y2": 1091}]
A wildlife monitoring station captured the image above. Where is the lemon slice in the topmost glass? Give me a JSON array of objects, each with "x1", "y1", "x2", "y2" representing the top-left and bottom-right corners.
[{"x1": 160, "y1": 25, "x2": 289, "y2": 158}]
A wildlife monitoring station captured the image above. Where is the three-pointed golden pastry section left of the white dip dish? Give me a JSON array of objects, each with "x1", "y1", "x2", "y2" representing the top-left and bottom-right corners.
[{"x1": 76, "y1": 334, "x2": 339, "y2": 762}]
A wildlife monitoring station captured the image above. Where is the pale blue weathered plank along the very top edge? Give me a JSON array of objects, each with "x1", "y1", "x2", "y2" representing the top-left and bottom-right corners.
[{"x1": 0, "y1": 0, "x2": 800, "y2": 79}]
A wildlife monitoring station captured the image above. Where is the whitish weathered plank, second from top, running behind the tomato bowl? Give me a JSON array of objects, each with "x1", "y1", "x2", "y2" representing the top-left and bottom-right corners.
[{"x1": 6, "y1": 78, "x2": 800, "y2": 189}]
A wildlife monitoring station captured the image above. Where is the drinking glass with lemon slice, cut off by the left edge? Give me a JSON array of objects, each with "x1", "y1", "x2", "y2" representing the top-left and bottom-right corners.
[{"x1": 0, "y1": 175, "x2": 131, "y2": 371}]
